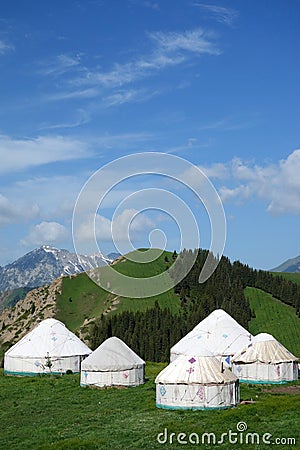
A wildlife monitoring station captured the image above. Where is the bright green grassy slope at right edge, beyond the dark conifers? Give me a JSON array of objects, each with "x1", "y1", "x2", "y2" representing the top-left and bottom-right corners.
[{"x1": 245, "y1": 287, "x2": 300, "y2": 357}]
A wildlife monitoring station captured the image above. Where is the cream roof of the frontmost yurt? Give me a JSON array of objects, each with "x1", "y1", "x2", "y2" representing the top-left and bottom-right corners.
[{"x1": 155, "y1": 354, "x2": 237, "y2": 384}]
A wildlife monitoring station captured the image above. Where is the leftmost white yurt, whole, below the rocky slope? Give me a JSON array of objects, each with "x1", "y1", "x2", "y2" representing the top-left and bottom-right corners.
[{"x1": 4, "y1": 319, "x2": 92, "y2": 375}]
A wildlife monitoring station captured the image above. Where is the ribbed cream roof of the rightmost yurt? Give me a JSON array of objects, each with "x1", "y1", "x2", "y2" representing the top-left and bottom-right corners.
[{"x1": 232, "y1": 333, "x2": 298, "y2": 364}]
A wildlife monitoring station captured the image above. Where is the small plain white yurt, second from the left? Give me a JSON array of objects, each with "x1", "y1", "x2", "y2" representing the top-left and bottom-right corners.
[{"x1": 80, "y1": 336, "x2": 145, "y2": 387}]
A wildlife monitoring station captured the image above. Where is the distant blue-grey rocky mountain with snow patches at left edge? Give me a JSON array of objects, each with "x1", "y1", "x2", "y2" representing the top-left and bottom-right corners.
[{"x1": 0, "y1": 245, "x2": 111, "y2": 292}]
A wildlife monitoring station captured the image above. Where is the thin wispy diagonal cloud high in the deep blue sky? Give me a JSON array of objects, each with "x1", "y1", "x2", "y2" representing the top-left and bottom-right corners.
[{"x1": 39, "y1": 28, "x2": 221, "y2": 107}]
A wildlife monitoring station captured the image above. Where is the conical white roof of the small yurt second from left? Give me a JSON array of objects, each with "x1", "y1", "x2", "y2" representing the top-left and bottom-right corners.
[{"x1": 81, "y1": 336, "x2": 145, "y2": 372}]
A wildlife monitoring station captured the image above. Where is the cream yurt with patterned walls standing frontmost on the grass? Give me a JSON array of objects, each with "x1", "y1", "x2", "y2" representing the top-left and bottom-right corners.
[{"x1": 155, "y1": 355, "x2": 240, "y2": 410}]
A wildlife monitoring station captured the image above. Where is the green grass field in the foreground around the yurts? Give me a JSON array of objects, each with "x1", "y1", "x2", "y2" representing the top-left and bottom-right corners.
[{"x1": 0, "y1": 363, "x2": 300, "y2": 450}]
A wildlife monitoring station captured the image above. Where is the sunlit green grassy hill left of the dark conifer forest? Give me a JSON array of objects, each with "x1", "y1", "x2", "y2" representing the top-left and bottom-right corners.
[{"x1": 56, "y1": 252, "x2": 179, "y2": 331}]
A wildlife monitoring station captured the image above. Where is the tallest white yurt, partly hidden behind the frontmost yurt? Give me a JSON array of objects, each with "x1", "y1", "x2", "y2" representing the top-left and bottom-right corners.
[{"x1": 170, "y1": 309, "x2": 252, "y2": 366}]
